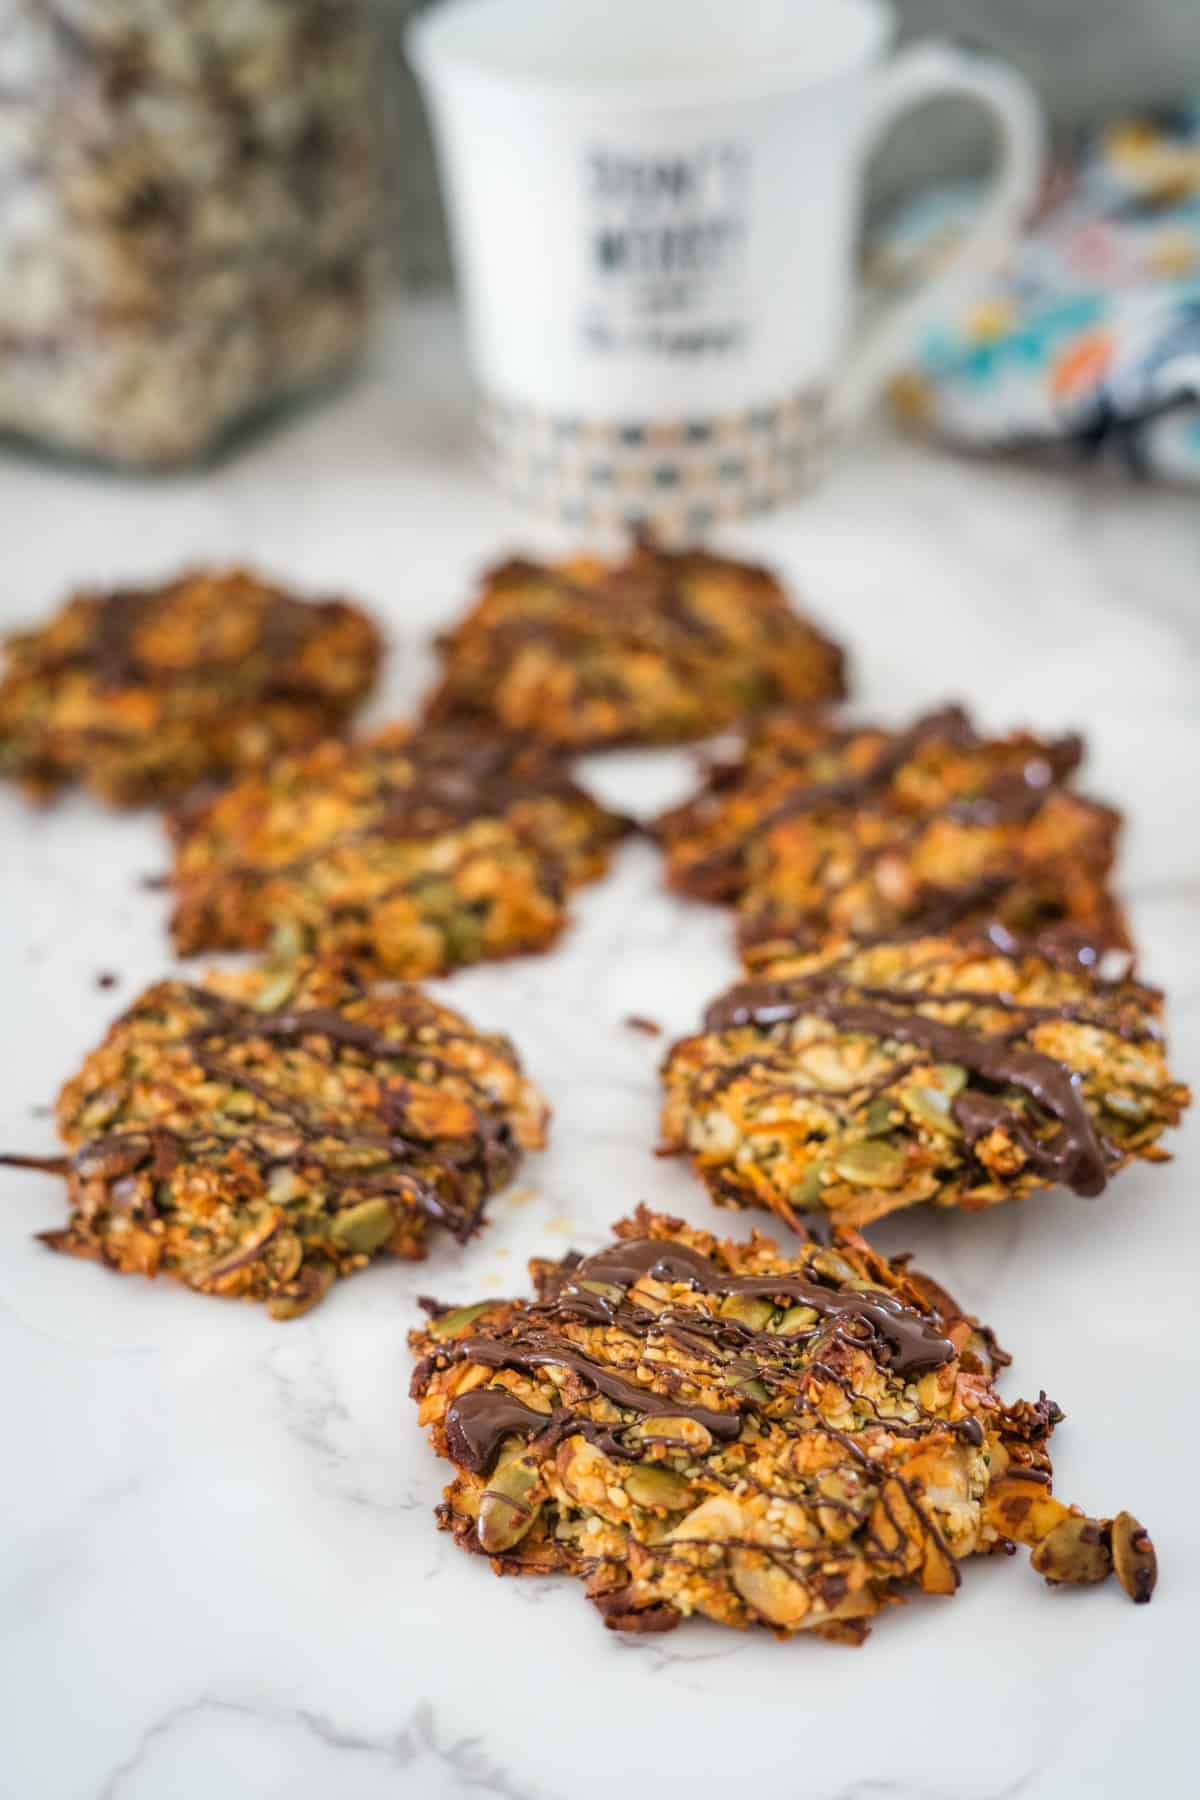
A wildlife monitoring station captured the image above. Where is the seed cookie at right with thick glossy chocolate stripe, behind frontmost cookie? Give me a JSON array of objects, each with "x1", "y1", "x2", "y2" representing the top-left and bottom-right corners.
[{"x1": 662, "y1": 938, "x2": 1189, "y2": 1226}]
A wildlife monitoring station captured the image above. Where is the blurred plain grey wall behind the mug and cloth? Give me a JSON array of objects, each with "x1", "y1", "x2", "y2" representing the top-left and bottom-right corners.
[{"x1": 379, "y1": 0, "x2": 1200, "y2": 288}]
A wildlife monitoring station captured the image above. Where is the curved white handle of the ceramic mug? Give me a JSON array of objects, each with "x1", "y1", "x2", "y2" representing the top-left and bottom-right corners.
[{"x1": 829, "y1": 40, "x2": 1045, "y2": 430}]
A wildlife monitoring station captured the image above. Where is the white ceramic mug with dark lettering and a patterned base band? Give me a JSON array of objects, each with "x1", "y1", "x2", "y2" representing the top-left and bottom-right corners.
[{"x1": 408, "y1": 0, "x2": 1043, "y2": 535}]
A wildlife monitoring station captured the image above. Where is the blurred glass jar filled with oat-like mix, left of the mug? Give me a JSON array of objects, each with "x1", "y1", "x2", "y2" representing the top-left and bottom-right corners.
[{"x1": 0, "y1": 0, "x2": 378, "y2": 466}]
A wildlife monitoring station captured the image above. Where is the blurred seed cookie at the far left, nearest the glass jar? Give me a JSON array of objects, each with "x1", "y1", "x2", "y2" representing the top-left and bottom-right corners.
[{"x1": 0, "y1": 569, "x2": 381, "y2": 806}]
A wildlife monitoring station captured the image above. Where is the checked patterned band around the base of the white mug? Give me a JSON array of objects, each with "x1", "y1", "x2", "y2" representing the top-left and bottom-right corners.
[{"x1": 480, "y1": 387, "x2": 826, "y2": 536}]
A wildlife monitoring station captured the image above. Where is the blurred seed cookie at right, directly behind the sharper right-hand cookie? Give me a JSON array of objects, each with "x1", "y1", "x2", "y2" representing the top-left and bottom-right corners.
[{"x1": 658, "y1": 706, "x2": 1128, "y2": 968}]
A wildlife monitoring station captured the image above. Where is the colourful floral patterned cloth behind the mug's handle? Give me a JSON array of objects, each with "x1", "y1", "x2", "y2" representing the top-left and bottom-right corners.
[{"x1": 871, "y1": 99, "x2": 1200, "y2": 481}]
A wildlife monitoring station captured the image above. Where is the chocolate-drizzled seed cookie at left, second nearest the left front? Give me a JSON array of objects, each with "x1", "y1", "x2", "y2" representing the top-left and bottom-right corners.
[{"x1": 17, "y1": 961, "x2": 547, "y2": 1319}]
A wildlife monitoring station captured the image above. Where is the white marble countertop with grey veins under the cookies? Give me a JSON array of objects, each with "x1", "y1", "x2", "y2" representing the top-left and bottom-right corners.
[{"x1": 0, "y1": 306, "x2": 1200, "y2": 1800}]
